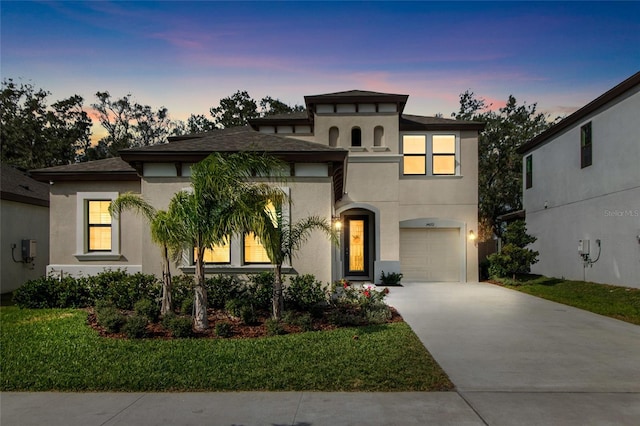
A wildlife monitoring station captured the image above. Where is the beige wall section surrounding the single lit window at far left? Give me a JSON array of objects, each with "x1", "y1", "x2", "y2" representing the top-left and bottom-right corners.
[{"x1": 48, "y1": 182, "x2": 146, "y2": 275}]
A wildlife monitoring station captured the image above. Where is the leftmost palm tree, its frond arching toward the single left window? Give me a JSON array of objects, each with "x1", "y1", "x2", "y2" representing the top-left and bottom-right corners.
[{"x1": 109, "y1": 192, "x2": 180, "y2": 315}]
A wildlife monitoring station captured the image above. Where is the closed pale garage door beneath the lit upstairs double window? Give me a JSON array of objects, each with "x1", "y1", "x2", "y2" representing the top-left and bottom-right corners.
[{"x1": 400, "y1": 228, "x2": 461, "y2": 281}]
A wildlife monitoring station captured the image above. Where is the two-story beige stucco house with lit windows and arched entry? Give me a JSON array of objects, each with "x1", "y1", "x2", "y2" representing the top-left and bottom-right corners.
[{"x1": 28, "y1": 90, "x2": 483, "y2": 282}]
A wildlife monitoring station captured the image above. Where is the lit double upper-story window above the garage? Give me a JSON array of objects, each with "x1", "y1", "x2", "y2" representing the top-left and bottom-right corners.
[{"x1": 402, "y1": 134, "x2": 460, "y2": 176}]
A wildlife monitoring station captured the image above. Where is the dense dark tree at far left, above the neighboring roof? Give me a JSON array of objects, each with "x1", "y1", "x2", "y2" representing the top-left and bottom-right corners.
[{"x1": 0, "y1": 79, "x2": 91, "y2": 169}]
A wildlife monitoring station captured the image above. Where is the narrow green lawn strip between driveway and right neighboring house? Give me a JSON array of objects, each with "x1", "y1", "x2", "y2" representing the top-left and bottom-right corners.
[{"x1": 497, "y1": 275, "x2": 640, "y2": 325}]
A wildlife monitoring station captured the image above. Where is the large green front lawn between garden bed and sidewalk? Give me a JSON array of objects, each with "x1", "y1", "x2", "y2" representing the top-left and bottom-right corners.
[{"x1": 0, "y1": 306, "x2": 453, "y2": 391}]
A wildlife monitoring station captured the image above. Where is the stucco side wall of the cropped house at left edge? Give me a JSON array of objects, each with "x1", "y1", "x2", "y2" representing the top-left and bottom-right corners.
[{"x1": 0, "y1": 200, "x2": 49, "y2": 293}]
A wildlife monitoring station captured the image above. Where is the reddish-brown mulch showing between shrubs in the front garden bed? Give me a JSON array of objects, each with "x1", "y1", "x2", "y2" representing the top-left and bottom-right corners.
[{"x1": 87, "y1": 307, "x2": 404, "y2": 340}]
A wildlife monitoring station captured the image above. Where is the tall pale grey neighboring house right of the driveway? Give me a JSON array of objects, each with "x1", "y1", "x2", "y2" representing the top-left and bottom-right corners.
[{"x1": 519, "y1": 73, "x2": 640, "y2": 288}]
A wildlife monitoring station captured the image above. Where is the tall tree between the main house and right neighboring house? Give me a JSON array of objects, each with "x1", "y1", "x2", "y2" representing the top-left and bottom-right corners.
[{"x1": 452, "y1": 91, "x2": 553, "y2": 240}]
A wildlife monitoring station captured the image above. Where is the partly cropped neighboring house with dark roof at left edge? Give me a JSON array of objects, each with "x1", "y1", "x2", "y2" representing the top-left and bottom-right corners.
[{"x1": 0, "y1": 164, "x2": 49, "y2": 293}]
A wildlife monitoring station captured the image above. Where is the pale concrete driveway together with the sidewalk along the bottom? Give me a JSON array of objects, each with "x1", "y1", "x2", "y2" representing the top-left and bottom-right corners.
[{"x1": 0, "y1": 283, "x2": 640, "y2": 426}]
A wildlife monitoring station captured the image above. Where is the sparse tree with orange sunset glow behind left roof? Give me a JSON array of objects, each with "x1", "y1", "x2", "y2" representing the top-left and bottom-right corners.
[{"x1": 87, "y1": 92, "x2": 172, "y2": 160}]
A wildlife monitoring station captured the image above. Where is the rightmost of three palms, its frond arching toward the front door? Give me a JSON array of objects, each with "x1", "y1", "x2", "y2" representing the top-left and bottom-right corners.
[{"x1": 253, "y1": 203, "x2": 339, "y2": 320}]
